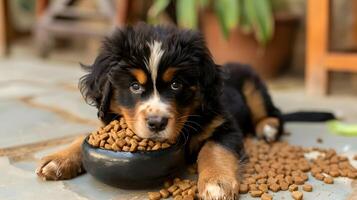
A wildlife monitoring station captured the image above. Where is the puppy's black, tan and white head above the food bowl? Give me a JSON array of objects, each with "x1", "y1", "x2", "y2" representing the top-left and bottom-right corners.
[{"x1": 80, "y1": 24, "x2": 219, "y2": 140}]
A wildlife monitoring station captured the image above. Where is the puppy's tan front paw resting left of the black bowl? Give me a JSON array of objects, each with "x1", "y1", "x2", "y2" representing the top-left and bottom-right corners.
[{"x1": 36, "y1": 153, "x2": 84, "y2": 180}]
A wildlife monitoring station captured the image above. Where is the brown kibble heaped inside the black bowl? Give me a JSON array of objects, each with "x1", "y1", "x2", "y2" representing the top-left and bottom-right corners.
[{"x1": 88, "y1": 118, "x2": 172, "y2": 152}]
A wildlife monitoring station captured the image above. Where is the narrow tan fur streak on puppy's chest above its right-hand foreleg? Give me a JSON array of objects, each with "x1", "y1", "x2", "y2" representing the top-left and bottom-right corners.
[{"x1": 190, "y1": 115, "x2": 225, "y2": 152}]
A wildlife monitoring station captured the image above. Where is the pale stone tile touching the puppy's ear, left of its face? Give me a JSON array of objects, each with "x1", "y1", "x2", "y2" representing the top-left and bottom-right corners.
[{"x1": 32, "y1": 90, "x2": 98, "y2": 122}]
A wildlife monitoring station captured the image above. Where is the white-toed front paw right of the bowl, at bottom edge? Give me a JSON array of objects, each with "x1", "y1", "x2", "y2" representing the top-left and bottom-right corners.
[{"x1": 198, "y1": 176, "x2": 239, "y2": 200}]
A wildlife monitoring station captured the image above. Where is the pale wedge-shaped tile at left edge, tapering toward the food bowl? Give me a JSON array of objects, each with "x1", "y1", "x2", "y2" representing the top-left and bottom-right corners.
[{"x1": 0, "y1": 100, "x2": 95, "y2": 148}]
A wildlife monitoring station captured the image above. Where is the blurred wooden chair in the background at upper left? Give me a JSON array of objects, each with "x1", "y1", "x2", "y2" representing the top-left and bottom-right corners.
[{"x1": 35, "y1": 0, "x2": 128, "y2": 57}]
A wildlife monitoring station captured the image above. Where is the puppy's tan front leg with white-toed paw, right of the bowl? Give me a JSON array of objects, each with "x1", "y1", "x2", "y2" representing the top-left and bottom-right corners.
[{"x1": 197, "y1": 141, "x2": 239, "y2": 200}]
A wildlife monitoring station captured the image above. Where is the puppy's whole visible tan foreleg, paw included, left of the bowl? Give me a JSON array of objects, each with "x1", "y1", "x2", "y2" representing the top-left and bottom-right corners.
[{"x1": 36, "y1": 136, "x2": 85, "y2": 180}]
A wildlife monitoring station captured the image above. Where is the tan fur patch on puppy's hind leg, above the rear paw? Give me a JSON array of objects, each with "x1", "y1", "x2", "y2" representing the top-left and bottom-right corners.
[{"x1": 243, "y1": 81, "x2": 267, "y2": 124}]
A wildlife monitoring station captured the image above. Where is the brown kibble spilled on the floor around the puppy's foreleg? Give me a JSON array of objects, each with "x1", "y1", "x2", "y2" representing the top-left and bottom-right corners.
[{"x1": 148, "y1": 139, "x2": 357, "y2": 200}]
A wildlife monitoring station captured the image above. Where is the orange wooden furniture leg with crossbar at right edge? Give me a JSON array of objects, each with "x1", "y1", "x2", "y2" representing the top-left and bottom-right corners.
[{"x1": 306, "y1": 0, "x2": 357, "y2": 95}]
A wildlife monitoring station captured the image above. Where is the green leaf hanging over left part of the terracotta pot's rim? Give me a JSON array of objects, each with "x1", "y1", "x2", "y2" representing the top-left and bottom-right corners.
[{"x1": 214, "y1": 0, "x2": 240, "y2": 38}]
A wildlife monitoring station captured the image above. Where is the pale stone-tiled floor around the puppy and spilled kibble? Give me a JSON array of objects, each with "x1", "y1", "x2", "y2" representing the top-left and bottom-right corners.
[{"x1": 0, "y1": 52, "x2": 357, "y2": 200}]
